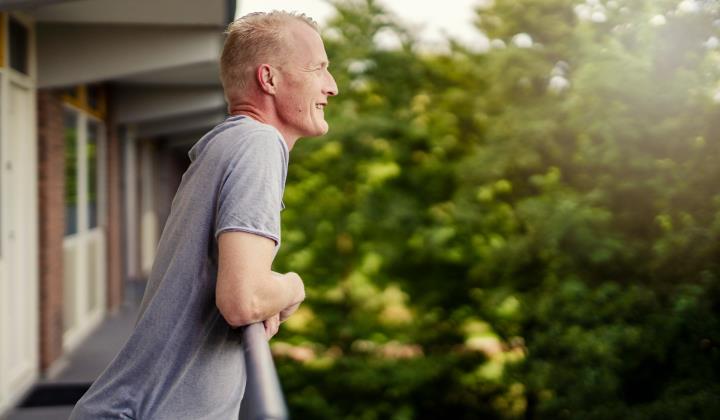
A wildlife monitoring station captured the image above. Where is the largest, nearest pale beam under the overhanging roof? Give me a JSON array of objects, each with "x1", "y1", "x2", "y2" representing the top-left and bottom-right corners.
[{"x1": 37, "y1": 24, "x2": 222, "y2": 87}]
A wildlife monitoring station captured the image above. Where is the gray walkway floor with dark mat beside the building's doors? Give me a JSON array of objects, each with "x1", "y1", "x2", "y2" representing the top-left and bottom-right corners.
[{"x1": 4, "y1": 282, "x2": 144, "y2": 420}]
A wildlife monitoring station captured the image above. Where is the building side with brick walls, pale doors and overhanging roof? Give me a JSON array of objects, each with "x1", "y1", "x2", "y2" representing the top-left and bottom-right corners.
[{"x1": 0, "y1": 0, "x2": 235, "y2": 414}]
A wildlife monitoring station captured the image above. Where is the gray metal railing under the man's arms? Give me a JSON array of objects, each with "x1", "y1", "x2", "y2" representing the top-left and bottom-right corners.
[{"x1": 240, "y1": 322, "x2": 288, "y2": 420}]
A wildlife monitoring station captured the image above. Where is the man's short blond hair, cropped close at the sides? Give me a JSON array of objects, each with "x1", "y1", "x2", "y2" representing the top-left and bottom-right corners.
[{"x1": 220, "y1": 10, "x2": 320, "y2": 96}]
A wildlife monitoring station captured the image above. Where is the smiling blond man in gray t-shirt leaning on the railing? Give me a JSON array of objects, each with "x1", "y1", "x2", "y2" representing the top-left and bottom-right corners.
[{"x1": 71, "y1": 12, "x2": 338, "y2": 420}]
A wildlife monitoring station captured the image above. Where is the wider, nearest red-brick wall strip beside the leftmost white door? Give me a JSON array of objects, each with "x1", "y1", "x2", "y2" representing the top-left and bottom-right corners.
[{"x1": 37, "y1": 89, "x2": 65, "y2": 370}]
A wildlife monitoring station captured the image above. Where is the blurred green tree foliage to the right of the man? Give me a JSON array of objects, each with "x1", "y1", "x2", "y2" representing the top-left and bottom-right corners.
[{"x1": 273, "y1": 0, "x2": 720, "y2": 419}]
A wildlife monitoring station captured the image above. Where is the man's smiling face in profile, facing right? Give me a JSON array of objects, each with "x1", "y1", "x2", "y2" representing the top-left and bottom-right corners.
[{"x1": 276, "y1": 22, "x2": 338, "y2": 137}]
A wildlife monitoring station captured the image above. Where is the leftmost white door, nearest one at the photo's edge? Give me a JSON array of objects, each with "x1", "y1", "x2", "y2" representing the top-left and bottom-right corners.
[{"x1": 0, "y1": 78, "x2": 39, "y2": 408}]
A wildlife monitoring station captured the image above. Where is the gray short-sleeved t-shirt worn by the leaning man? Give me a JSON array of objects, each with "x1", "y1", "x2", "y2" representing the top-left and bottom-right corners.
[{"x1": 70, "y1": 116, "x2": 289, "y2": 420}]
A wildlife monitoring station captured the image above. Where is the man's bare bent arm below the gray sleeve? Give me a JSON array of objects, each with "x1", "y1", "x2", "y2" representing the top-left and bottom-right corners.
[{"x1": 215, "y1": 232, "x2": 305, "y2": 327}]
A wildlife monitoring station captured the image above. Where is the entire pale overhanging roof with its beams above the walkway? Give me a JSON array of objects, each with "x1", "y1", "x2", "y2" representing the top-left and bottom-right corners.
[{"x1": 25, "y1": 0, "x2": 236, "y2": 145}]
